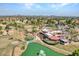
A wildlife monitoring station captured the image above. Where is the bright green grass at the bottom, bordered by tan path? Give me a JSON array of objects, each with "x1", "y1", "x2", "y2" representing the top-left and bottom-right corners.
[{"x1": 22, "y1": 43, "x2": 64, "y2": 56}]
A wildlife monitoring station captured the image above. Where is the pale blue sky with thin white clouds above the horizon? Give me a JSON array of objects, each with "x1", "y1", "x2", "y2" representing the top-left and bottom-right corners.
[{"x1": 0, "y1": 3, "x2": 79, "y2": 16}]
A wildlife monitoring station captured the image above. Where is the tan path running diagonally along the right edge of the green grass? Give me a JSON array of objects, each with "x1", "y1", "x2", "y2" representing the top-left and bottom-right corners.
[{"x1": 33, "y1": 36, "x2": 72, "y2": 55}]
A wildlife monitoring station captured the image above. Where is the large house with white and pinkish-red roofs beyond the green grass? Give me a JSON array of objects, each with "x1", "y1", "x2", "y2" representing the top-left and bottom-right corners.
[{"x1": 42, "y1": 29, "x2": 63, "y2": 41}]
